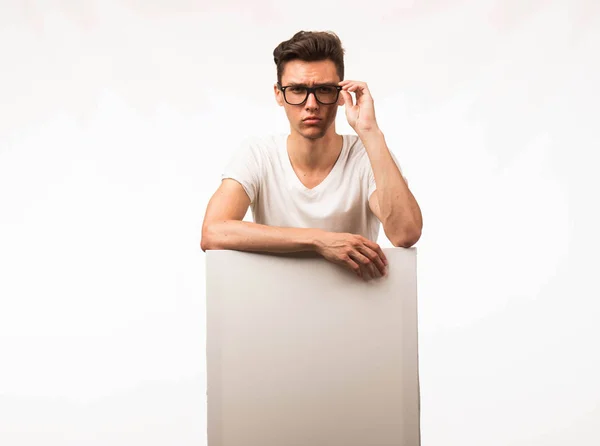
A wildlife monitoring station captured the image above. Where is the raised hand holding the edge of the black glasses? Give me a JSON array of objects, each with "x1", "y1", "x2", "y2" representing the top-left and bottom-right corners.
[{"x1": 339, "y1": 80, "x2": 378, "y2": 135}]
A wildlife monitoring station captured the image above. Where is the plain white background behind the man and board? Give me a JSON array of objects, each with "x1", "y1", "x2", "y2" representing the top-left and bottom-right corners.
[{"x1": 0, "y1": 0, "x2": 600, "y2": 446}]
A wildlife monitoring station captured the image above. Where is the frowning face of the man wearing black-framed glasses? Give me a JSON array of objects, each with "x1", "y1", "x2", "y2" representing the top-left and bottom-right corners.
[{"x1": 275, "y1": 60, "x2": 344, "y2": 139}]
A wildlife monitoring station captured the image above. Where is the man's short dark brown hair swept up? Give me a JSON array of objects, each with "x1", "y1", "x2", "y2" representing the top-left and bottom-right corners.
[{"x1": 273, "y1": 31, "x2": 344, "y2": 82}]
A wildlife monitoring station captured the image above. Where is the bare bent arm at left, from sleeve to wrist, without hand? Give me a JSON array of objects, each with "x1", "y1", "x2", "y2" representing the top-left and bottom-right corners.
[{"x1": 200, "y1": 178, "x2": 325, "y2": 253}]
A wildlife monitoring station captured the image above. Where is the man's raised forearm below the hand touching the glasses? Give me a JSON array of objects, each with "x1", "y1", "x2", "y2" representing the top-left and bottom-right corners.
[{"x1": 360, "y1": 129, "x2": 423, "y2": 246}]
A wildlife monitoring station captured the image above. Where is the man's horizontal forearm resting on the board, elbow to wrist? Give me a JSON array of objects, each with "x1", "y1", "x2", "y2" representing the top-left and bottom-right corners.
[{"x1": 201, "y1": 220, "x2": 323, "y2": 253}]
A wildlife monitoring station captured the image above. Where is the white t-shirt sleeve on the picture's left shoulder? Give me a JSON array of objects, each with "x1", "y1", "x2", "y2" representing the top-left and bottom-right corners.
[{"x1": 221, "y1": 139, "x2": 262, "y2": 204}]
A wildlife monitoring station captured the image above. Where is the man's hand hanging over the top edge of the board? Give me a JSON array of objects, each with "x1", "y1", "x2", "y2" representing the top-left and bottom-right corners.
[{"x1": 316, "y1": 231, "x2": 388, "y2": 280}]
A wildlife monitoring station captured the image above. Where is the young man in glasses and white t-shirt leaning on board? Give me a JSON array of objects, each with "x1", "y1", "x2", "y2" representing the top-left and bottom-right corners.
[{"x1": 201, "y1": 31, "x2": 423, "y2": 280}]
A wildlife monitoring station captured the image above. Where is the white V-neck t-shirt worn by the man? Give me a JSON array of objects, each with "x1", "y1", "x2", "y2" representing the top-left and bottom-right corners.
[{"x1": 221, "y1": 134, "x2": 400, "y2": 242}]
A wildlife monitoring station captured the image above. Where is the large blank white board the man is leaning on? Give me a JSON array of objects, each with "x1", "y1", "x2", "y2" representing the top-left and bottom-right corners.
[{"x1": 206, "y1": 248, "x2": 420, "y2": 446}]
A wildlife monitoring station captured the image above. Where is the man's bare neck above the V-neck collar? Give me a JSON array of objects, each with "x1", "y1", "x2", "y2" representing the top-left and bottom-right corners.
[{"x1": 287, "y1": 129, "x2": 343, "y2": 172}]
